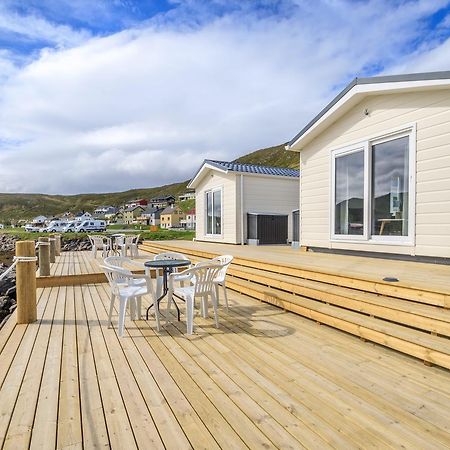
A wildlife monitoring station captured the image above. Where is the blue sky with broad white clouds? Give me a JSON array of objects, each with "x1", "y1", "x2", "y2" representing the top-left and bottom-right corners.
[{"x1": 0, "y1": 0, "x2": 450, "y2": 194}]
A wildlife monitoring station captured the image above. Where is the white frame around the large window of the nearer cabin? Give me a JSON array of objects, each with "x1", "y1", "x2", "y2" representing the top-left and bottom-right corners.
[{"x1": 330, "y1": 124, "x2": 417, "y2": 246}]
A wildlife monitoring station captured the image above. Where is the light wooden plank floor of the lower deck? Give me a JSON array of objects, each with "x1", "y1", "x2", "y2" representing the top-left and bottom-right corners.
[{"x1": 0, "y1": 253, "x2": 450, "y2": 449}]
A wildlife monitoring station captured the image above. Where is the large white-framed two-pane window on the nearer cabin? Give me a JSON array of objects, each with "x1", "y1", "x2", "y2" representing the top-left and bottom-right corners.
[{"x1": 331, "y1": 128, "x2": 415, "y2": 244}]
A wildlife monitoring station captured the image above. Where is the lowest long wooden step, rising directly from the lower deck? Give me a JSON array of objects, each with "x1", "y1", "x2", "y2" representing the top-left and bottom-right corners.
[{"x1": 227, "y1": 277, "x2": 450, "y2": 369}]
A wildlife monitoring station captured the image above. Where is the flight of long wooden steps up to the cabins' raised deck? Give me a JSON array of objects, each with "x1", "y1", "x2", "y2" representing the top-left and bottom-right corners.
[{"x1": 145, "y1": 243, "x2": 450, "y2": 368}]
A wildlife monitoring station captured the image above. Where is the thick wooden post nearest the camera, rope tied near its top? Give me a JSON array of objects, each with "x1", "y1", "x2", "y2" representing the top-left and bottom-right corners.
[{"x1": 16, "y1": 241, "x2": 37, "y2": 323}]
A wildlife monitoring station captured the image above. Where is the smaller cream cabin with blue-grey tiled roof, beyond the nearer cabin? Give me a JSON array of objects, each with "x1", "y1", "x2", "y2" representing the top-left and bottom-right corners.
[{"x1": 188, "y1": 160, "x2": 299, "y2": 244}]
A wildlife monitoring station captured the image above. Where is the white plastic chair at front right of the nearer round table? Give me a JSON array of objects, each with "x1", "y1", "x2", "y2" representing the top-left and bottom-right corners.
[{"x1": 166, "y1": 263, "x2": 222, "y2": 334}]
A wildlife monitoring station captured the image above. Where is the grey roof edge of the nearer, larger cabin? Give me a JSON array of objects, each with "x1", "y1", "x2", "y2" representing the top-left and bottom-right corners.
[{"x1": 288, "y1": 71, "x2": 450, "y2": 147}]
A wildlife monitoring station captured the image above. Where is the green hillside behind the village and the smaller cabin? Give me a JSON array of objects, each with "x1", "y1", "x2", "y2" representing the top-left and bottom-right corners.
[{"x1": 0, "y1": 144, "x2": 298, "y2": 223}]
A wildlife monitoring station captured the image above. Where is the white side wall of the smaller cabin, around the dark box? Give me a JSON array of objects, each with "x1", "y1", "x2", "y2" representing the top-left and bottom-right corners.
[{"x1": 238, "y1": 175, "x2": 299, "y2": 241}]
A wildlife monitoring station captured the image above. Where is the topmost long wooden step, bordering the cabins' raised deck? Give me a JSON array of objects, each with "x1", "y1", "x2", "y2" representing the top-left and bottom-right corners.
[{"x1": 141, "y1": 241, "x2": 450, "y2": 308}]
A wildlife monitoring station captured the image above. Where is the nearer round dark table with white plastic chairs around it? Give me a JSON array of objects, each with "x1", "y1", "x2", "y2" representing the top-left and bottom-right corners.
[{"x1": 97, "y1": 244, "x2": 233, "y2": 336}]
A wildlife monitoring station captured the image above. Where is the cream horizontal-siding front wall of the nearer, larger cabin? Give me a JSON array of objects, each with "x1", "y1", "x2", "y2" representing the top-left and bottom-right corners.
[{"x1": 300, "y1": 90, "x2": 450, "y2": 257}]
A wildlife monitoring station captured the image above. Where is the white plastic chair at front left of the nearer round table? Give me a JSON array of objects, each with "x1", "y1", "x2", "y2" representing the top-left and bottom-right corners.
[{"x1": 100, "y1": 265, "x2": 160, "y2": 337}]
